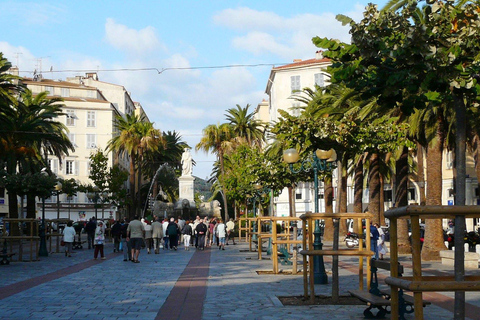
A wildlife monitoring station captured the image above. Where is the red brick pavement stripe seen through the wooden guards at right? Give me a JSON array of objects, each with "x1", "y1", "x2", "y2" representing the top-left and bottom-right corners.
[{"x1": 339, "y1": 261, "x2": 480, "y2": 319}]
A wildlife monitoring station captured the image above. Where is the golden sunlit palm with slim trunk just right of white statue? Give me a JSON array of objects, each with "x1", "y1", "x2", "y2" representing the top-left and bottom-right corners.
[{"x1": 195, "y1": 123, "x2": 233, "y2": 220}]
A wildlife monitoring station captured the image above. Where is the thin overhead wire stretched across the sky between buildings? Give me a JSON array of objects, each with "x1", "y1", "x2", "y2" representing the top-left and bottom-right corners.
[{"x1": 20, "y1": 62, "x2": 287, "y2": 74}]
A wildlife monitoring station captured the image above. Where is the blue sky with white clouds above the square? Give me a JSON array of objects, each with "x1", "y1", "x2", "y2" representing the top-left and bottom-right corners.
[{"x1": 0, "y1": 0, "x2": 387, "y2": 178}]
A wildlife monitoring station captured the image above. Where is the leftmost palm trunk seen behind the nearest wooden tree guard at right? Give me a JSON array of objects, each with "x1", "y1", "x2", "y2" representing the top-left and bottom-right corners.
[{"x1": 395, "y1": 147, "x2": 412, "y2": 254}]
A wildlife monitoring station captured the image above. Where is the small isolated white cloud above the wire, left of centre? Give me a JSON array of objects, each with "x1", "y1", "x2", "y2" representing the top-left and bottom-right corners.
[{"x1": 105, "y1": 18, "x2": 165, "y2": 56}]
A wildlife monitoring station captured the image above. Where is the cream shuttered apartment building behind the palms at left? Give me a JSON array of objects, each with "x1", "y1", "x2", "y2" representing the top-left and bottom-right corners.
[{"x1": 22, "y1": 76, "x2": 122, "y2": 220}]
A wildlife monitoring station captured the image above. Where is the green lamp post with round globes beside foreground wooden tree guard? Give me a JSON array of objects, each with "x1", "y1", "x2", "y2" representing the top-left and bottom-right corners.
[{"x1": 283, "y1": 149, "x2": 337, "y2": 284}]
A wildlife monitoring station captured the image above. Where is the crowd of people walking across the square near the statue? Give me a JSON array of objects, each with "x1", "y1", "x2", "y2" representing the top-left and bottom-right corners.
[{"x1": 63, "y1": 216, "x2": 236, "y2": 263}]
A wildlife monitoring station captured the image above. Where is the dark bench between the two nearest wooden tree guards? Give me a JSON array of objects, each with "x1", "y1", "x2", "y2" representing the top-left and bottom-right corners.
[{"x1": 348, "y1": 259, "x2": 431, "y2": 320}]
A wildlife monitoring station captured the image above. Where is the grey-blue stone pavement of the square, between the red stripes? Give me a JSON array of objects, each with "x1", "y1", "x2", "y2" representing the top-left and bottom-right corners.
[{"x1": 0, "y1": 243, "x2": 480, "y2": 320}]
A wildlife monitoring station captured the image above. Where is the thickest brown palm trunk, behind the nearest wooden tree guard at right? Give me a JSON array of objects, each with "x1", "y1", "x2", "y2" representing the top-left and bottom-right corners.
[{"x1": 422, "y1": 126, "x2": 445, "y2": 261}]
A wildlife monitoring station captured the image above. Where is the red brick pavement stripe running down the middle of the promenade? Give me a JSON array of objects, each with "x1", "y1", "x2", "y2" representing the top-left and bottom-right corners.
[{"x1": 155, "y1": 249, "x2": 210, "y2": 320}]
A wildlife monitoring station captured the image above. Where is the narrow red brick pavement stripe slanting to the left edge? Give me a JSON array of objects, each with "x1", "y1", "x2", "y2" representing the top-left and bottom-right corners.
[{"x1": 0, "y1": 254, "x2": 116, "y2": 300}]
